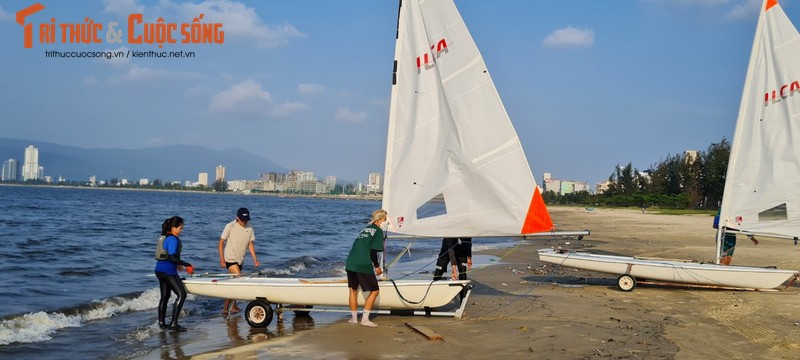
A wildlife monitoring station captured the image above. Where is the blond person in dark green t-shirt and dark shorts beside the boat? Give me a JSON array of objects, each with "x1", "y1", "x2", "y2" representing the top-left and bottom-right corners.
[{"x1": 345, "y1": 210, "x2": 389, "y2": 327}]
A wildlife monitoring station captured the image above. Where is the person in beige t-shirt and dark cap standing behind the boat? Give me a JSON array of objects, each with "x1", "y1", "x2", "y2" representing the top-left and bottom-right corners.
[{"x1": 219, "y1": 208, "x2": 261, "y2": 314}]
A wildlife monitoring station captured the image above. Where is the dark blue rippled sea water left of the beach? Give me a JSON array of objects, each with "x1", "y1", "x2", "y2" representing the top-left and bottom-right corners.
[{"x1": 0, "y1": 186, "x2": 506, "y2": 359}]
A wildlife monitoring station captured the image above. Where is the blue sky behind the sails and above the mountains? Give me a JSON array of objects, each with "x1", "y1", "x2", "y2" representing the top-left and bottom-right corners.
[{"x1": 0, "y1": 0, "x2": 800, "y2": 188}]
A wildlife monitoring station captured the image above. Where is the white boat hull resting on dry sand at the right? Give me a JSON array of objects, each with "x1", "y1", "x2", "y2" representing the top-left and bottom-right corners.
[{"x1": 539, "y1": 249, "x2": 798, "y2": 289}]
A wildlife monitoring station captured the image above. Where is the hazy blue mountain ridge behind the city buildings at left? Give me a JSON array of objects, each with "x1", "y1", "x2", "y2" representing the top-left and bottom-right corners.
[{"x1": 0, "y1": 137, "x2": 287, "y2": 182}]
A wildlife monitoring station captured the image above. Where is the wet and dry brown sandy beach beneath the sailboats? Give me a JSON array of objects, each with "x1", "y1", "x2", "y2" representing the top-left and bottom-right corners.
[{"x1": 147, "y1": 207, "x2": 800, "y2": 359}]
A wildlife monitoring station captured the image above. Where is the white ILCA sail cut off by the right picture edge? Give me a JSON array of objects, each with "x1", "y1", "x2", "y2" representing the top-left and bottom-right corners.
[{"x1": 720, "y1": 0, "x2": 800, "y2": 242}]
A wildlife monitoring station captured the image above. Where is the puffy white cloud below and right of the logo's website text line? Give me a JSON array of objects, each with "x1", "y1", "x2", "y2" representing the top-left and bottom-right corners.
[{"x1": 208, "y1": 79, "x2": 306, "y2": 118}]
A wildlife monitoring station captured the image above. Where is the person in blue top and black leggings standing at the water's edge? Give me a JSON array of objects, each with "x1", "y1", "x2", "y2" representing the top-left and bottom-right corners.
[{"x1": 155, "y1": 216, "x2": 194, "y2": 331}]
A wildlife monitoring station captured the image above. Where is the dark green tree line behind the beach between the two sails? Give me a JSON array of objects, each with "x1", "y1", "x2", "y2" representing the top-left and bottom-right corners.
[{"x1": 543, "y1": 138, "x2": 731, "y2": 209}]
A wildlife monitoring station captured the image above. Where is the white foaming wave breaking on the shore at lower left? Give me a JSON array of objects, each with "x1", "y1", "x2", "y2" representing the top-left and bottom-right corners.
[{"x1": 0, "y1": 288, "x2": 165, "y2": 345}]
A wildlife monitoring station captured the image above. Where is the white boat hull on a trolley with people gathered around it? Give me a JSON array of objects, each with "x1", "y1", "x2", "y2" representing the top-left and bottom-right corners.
[{"x1": 183, "y1": 276, "x2": 470, "y2": 309}]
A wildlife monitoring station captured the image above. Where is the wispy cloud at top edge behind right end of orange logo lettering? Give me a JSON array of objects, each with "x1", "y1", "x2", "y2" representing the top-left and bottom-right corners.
[{"x1": 167, "y1": 0, "x2": 307, "y2": 48}]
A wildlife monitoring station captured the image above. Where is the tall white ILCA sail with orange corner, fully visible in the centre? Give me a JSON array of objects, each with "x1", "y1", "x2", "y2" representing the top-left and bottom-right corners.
[{"x1": 383, "y1": 0, "x2": 553, "y2": 237}]
